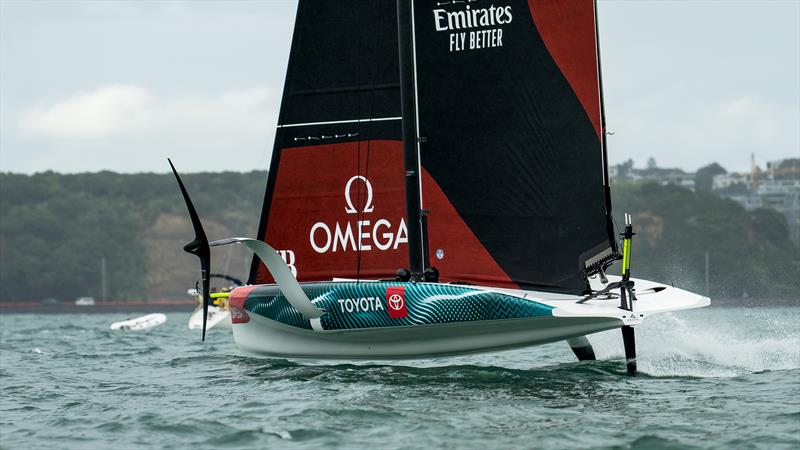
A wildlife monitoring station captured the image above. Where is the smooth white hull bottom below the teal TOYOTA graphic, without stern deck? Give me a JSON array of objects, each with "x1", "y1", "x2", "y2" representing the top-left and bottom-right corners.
[{"x1": 233, "y1": 316, "x2": 622, "y2": 359}]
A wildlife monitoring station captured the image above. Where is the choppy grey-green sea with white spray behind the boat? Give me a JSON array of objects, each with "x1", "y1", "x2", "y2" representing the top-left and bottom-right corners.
[{"x1": 0, "y1": 307, "x2": 800, "y2": 450}]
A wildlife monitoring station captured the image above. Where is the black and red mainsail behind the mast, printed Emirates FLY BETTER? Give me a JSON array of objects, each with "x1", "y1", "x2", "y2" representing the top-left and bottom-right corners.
[{"x1": 413, "y1": 0, "x2": 616, "y2": 293}]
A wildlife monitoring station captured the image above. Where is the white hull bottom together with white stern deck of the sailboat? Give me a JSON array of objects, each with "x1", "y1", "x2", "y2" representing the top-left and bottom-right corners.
[{"x1": 233, "y1": 280, "x2": 710, "y2": 359}]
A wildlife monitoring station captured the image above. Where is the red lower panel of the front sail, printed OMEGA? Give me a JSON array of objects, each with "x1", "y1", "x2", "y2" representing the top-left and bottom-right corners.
[{"x1": 255, "y1": 140, "x2": 408, "y2": 283}]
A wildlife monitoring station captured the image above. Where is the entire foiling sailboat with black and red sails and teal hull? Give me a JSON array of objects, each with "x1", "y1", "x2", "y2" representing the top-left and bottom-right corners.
[{"x1": 170, "y1": 0, "x2": 710, "y2": 372}]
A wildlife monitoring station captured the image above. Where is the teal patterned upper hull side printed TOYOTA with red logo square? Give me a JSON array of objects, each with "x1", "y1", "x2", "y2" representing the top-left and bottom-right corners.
[{"x1": 244, "y1": 282, "x2": 553, "y2": 330}]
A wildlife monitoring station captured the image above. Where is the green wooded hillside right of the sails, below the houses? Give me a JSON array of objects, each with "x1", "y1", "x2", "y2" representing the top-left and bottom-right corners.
[{"x1": 611, "y1": 184, "x2": 800, "y2": 299}]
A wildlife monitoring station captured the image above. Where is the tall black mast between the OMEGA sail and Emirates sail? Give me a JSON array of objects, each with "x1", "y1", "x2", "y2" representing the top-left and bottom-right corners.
[{"x1": 397, "y1": 0, "x2": 425, "y2": 280}]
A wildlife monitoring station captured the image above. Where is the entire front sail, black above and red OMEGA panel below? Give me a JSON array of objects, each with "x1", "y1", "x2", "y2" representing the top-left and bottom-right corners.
[{"x1": 250, "y1": 0, "x2": 408, "y2": 283}]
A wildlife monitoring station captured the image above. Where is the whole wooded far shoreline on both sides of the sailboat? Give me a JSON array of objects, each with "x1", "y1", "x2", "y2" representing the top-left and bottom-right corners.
[{"x1": 0, "y1": 171, "x2": 800, "y2": 301}]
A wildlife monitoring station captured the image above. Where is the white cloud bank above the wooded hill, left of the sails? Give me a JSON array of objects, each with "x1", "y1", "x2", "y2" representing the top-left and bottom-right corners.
[{"x1": 0, "y1": 84, "x2": 280, "y2": 172}]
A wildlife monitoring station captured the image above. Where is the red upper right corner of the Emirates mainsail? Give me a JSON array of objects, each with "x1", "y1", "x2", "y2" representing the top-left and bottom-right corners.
[{"x1": 528, "y1": 0, "x2": 601, "y2": 136}]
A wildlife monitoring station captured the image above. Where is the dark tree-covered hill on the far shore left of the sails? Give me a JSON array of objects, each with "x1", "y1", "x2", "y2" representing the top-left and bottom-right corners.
[{"x1": 0, "y1": 171, "x2": 266, "y2": 300}]
